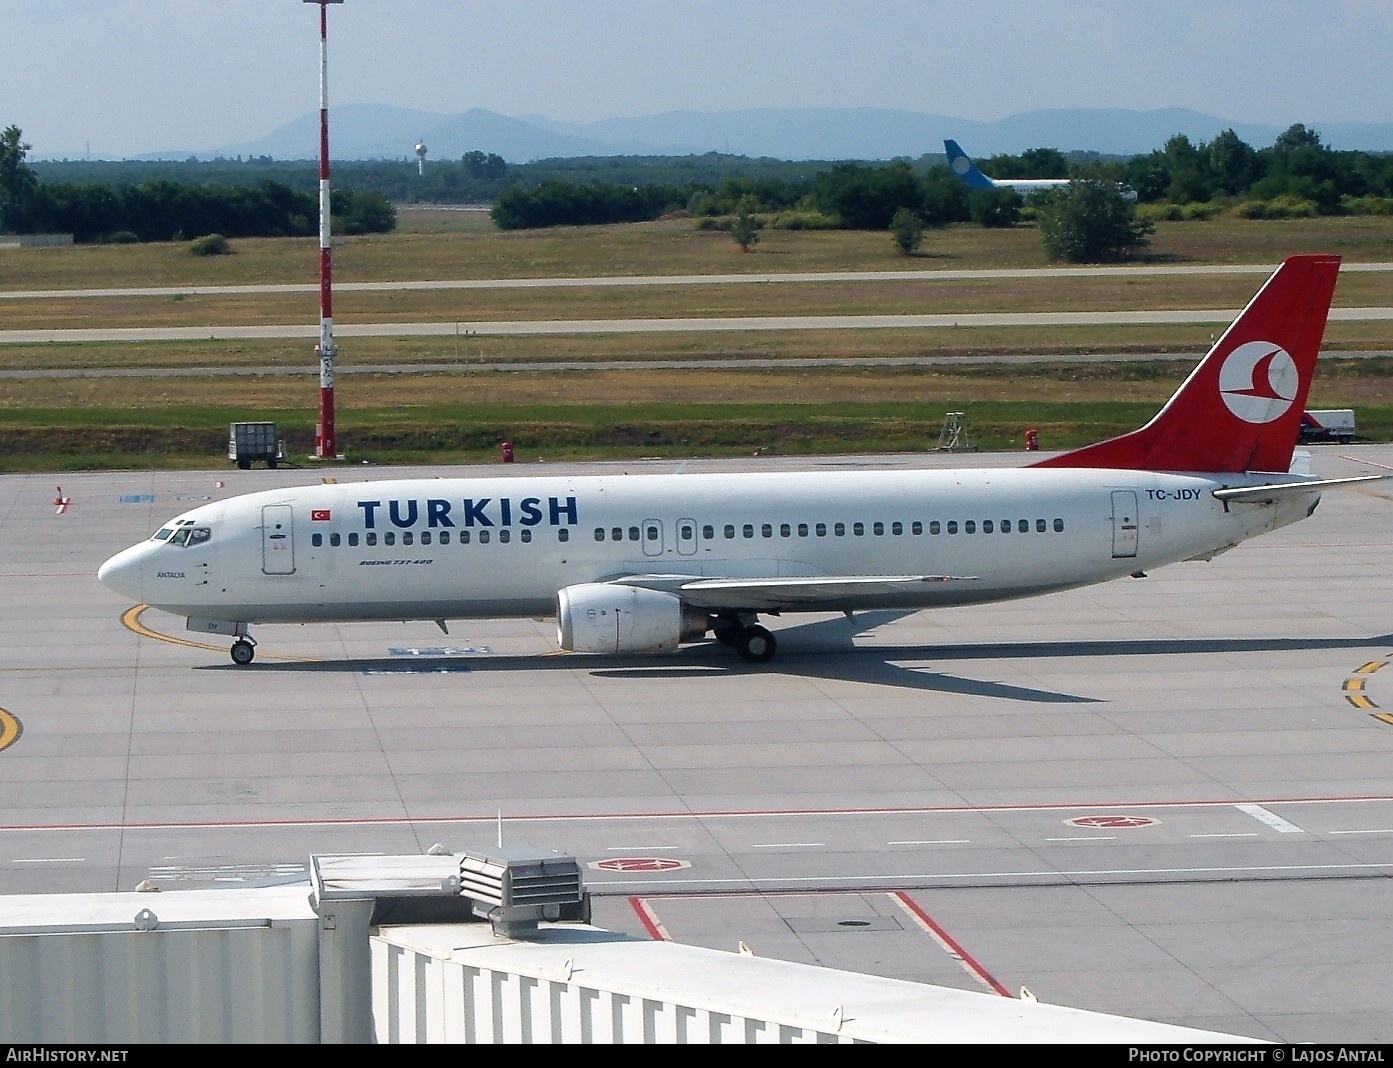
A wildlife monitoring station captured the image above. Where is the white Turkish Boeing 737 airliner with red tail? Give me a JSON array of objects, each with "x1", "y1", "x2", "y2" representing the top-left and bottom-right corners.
[{"x1": 98, "y1": 255, "x2": 1380, "y2": 664}]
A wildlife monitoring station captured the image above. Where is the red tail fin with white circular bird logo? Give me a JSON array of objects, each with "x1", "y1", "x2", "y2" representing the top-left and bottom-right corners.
[{"x1": 1034, "y1": 256, "x2": 1340, "y2": 472}]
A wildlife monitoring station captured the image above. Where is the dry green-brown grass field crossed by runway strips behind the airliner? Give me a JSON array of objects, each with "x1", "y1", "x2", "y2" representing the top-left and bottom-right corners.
[{"x1": 0, "y1": 212, "x2": 1393, "y2": 471}]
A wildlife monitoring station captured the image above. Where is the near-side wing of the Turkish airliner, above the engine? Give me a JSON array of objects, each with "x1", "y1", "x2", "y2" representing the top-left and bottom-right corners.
[{"x1": 614, "y1": 575, "x2": 976, "y2": 611}]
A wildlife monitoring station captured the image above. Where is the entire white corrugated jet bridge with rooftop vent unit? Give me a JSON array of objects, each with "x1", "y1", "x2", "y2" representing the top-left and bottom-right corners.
[{"x1": 0, "y1": 847, "x2": 1251, "y2": 1046}]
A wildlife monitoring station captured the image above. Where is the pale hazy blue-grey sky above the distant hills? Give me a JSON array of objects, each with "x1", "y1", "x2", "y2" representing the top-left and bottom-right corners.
[{"x1": 10, "y1": 0, "x2": 1393, "y2": 159}]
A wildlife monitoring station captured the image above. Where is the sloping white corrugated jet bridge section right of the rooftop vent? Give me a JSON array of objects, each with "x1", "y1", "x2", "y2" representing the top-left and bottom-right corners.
[{"x1": 372, "y1": 923, "x2": 1252, "y2": 1044}]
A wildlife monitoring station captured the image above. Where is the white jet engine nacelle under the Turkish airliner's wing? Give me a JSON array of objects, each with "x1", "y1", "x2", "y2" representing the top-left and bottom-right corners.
[{"x1": 556, "y1": 582, "x2": 710, "y2": 653}]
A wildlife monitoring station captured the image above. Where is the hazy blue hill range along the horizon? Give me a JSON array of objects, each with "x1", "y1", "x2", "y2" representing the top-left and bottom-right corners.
[{"x1": 138, "y1": 104, "x2": 1393, "y2": 163}]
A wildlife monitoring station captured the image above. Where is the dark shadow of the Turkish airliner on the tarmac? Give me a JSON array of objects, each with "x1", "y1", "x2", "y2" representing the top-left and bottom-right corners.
[{"x1": 190, "y1": 618, "x2": 1393, "y2": 703}]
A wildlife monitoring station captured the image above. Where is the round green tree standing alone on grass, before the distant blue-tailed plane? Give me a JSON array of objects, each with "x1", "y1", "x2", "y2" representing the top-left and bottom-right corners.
[{"x1": 1032, "y1": 178, "x2": 1156, "y2": 263}]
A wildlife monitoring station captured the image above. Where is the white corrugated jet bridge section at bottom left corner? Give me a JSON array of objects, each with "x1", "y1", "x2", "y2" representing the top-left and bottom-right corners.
[{"x1": 0, "y1": 887, "x2": 319, "y2": 1044}]
